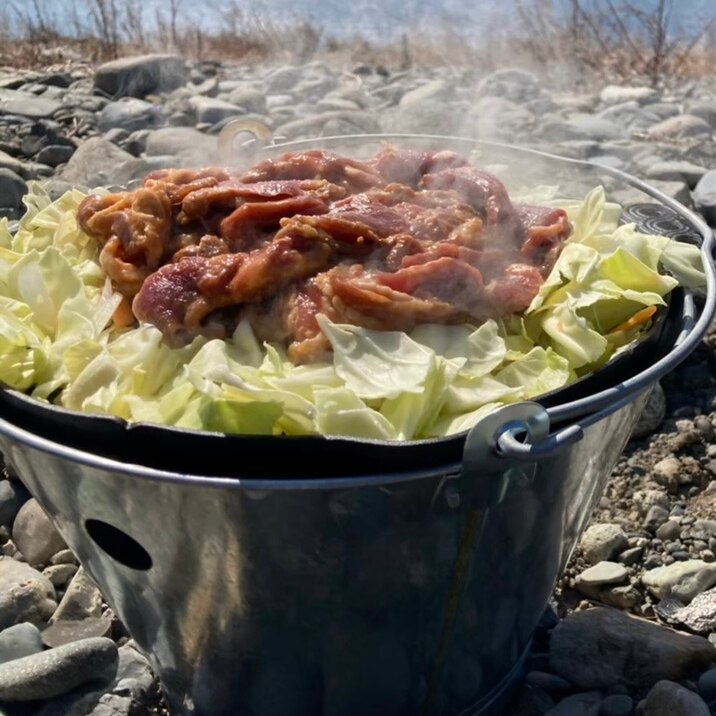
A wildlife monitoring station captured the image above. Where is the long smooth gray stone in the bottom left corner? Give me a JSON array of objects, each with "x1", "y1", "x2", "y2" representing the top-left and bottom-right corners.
[{"x1": 0, "y1": 637, "x2": 118, "y2": 702}]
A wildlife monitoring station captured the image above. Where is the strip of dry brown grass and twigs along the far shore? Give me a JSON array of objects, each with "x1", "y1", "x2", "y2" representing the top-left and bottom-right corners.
[{"x1": 0, "y1": 0, "x2": 716, "y2": 87}]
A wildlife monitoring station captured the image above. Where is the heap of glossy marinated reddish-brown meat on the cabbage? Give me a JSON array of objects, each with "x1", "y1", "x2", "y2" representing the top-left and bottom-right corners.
[{"x1": 78, "y1": 147, "x2": 571, "y2": 363}]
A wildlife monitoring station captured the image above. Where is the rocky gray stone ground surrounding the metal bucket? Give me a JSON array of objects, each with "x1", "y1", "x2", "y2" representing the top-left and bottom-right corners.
[{"x1": 0, "y1": 51, "x2": 716, "y2": 716}]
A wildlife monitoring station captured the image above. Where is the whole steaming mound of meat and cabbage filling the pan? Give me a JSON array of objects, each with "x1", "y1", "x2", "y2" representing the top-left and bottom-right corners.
[{"x1": 0, "y1": 147, "x2": 703, "y2": 440}]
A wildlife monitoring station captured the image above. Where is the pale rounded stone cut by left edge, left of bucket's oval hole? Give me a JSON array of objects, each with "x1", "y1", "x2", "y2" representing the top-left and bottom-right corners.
[{"x1": 0, "y1": 557, "x2": 57, "y2": 629}]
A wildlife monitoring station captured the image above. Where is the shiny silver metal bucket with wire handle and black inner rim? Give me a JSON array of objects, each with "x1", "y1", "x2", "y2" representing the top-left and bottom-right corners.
[{"x1": 0, "y1": 137, "x2": 716, "y2": 716}]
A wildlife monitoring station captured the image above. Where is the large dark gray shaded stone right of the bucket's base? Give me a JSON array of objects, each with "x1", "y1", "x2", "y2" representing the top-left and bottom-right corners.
[{"x1": 549, "y1": 608, "x2": 716, "y2": 689}]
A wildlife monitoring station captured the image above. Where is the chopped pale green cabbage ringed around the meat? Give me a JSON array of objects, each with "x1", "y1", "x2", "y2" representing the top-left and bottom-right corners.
[{"x1": 0, "y1": 183, "x2": 705, "y2": 440}]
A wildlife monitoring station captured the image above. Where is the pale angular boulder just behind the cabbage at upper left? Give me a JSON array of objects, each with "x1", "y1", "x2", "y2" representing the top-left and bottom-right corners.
[{"x1": 57, "y1": 136, "x2": 149, "y2": 189}]
